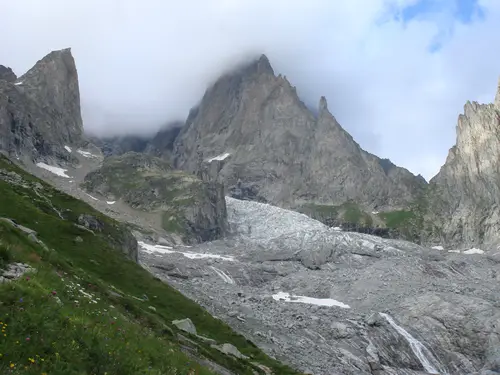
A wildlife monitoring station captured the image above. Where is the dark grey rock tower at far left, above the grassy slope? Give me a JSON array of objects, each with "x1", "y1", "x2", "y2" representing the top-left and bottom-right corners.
[{"x1": 0, "y1": 49, "x2": 83, "y2": 162}]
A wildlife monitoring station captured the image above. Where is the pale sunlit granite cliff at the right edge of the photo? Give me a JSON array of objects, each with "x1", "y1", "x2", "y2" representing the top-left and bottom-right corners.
[{"x1": 425, "y1": 79, "x2": 500, "y2": 250}]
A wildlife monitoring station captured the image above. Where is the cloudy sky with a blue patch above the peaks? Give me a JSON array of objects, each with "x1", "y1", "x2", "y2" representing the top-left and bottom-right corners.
[{"x1": 0, "y1": 0, "x2": 500, "y2": 179}]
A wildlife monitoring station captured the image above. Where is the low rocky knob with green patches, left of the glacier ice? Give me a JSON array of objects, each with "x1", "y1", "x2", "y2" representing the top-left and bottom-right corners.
[{"x1": 82, "y1": 152, "x2": 227, "y2": 243}]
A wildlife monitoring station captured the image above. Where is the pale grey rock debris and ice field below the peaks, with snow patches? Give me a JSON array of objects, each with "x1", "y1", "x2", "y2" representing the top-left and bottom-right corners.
[{"x1": 139, "y1": 198, "x2": 500, "y2": 375}]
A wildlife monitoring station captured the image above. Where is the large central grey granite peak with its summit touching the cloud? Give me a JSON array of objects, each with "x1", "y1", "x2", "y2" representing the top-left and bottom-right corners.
[{"x1": 173, "y1": 56, "x2": 425, "y2": 209}]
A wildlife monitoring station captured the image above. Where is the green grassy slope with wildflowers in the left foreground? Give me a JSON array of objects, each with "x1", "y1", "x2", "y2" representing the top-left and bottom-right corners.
[{"x1": 0, "y1": 156, "x2": 297, "y2": 375}]
